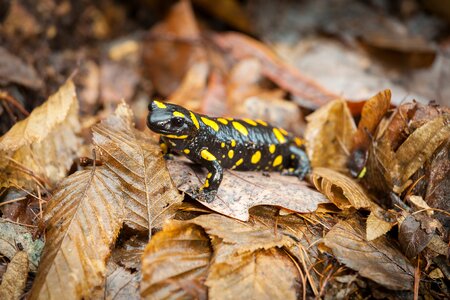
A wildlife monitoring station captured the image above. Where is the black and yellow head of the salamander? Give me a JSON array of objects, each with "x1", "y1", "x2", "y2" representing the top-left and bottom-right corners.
[{"x1": 147, "y1": 100, "x2": 198, "y2": 139}]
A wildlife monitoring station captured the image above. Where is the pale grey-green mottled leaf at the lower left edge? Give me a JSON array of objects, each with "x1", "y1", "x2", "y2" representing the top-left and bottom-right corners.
[{"x1": 0, "y1": 219, "x2": 44, "y2": 272}]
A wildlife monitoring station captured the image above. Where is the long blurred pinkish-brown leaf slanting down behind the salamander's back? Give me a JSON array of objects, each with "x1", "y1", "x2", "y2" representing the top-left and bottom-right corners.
[{"x1": 213, "y1": 32, "x2": 339, "y2": 108}]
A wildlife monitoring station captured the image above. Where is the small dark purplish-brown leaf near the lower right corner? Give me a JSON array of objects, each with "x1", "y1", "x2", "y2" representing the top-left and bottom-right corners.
[{"x1": 398, "y1": 215, "x2": 434, "y2": 258}]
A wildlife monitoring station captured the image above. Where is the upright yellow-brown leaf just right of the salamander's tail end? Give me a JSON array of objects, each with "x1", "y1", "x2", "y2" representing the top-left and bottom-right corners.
[{"x1": 305, "y1": 100, "x2": 356, "y2": 172}]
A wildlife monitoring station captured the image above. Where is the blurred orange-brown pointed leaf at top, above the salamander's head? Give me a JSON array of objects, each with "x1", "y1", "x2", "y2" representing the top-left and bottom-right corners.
[{"x1": 143, "y1": 0, "x2": 206, "y2": 97}]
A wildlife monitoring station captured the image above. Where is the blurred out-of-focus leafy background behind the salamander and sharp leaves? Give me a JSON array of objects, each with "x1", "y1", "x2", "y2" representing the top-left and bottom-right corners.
[{"x1": 0, "y1": 0, "x2": 450, "y2": 134}]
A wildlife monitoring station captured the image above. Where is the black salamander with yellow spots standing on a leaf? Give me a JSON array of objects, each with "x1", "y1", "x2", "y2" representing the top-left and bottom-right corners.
[{"x1": 147, "y1": 100, "x2": 310, "y2": 202}]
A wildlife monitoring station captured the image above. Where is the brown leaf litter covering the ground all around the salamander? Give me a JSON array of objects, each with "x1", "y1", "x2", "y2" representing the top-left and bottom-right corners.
[{"x1": 0, "y1": 0, "x2": 450, "y2": 299}]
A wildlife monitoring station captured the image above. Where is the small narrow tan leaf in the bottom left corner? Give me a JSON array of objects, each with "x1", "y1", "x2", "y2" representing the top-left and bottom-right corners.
[{"x1": 0, "y1": 251, "x2": 28, "y2": 300}]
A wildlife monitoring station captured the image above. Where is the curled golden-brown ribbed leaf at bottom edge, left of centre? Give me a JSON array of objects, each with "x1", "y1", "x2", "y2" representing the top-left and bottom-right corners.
[{"x1": 141, "y1": 221, "x2": 212, "y2": 299}]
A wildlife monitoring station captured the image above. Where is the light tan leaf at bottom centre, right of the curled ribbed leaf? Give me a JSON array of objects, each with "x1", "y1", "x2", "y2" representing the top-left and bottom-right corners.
[{"x1": 206, "y1": 244, "x2": 300, "y2": 300}]
